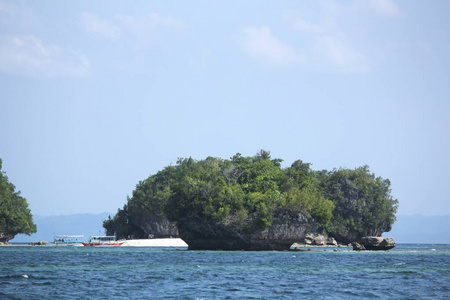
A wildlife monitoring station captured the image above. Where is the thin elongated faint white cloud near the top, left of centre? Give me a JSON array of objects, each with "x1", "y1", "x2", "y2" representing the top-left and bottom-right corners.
[{"x1": 80, "y1": 12, "x2": 185, "y2": 39}]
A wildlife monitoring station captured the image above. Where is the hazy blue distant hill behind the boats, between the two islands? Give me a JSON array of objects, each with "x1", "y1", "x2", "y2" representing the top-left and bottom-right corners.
[{"x1": 10, "y1": 213, "x2": 114, "y2": 243}]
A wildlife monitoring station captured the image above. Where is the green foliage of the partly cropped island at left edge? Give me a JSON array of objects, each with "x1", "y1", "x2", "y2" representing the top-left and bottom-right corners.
[{"x1": 0, "y1": 159, "x2": 36, "y2": 235}]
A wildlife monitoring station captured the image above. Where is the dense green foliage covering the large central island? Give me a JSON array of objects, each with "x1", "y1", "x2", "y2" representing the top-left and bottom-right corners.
[{"x1": 104, "y1": 150, "x2": 397, "y2": 240}]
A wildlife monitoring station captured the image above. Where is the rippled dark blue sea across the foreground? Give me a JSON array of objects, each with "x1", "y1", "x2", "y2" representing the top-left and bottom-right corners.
[{"x1": 0, "y1": 244, "x2": 450, "y2": 299}]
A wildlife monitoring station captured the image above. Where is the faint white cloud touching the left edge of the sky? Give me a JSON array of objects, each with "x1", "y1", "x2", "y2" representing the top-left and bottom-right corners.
[{"x1": 0, "y1": 35, "x2": 90, "y2": 77}]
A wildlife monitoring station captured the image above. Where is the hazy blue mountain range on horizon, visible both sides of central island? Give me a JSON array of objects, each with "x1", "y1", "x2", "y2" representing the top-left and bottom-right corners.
[{"x1": 11, "y1": 213, "x2": 450, "y2": 244}]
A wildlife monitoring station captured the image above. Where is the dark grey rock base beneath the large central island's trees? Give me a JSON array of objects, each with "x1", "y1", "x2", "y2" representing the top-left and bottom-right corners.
[{"x1": 130, "y1": 211, "x2": 395, "y2": 251}]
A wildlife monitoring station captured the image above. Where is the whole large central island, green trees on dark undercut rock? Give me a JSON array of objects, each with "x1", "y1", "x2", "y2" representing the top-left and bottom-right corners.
[{"x1": 103, "y1": 150, "x2": 398, "y2": 250}]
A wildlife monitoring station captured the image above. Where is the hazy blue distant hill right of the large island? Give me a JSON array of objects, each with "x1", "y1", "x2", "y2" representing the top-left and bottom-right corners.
[{"x1": 383, "y1": 215, "x2": 450, "y2": 244}]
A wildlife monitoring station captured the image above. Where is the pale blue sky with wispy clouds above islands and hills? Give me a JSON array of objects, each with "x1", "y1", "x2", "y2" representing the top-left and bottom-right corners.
[{"x1": 0, "y1": 0, "x2": 450, "y2": 216}]
